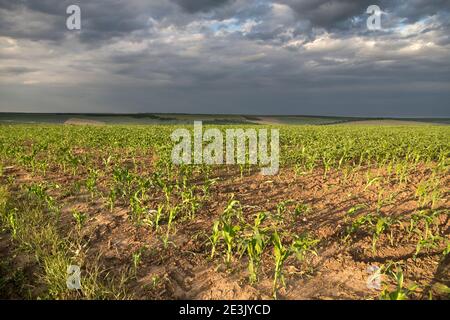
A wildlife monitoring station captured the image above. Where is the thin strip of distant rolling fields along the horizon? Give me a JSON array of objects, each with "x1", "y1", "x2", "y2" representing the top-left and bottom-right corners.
[{"x1": 0, "y1": 113, "x2": 450, "y2": 125}]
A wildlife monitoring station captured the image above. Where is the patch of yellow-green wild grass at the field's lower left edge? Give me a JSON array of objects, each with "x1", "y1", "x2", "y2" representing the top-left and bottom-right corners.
[{"x1": 0, "y1": 187, "x2": 128, "y2": 299}]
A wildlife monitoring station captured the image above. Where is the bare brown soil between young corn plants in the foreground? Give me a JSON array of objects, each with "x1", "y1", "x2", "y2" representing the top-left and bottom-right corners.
[{"x1": 0, "y1": 162, "x2": 450, "y2": 299}]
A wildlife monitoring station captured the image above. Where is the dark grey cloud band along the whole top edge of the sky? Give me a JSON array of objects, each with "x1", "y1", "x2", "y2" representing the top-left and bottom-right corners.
[{"x1": 0, "y1": 0, "x2": 450, "y2": 43}]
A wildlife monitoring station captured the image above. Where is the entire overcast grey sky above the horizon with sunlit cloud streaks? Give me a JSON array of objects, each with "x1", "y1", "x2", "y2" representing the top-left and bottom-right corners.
[{"x1": 0, "y1": 0, "x2": 450, "y2": 117}]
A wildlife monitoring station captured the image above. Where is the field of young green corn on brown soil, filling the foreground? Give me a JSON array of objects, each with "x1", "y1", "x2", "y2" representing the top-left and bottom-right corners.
[{"x1": 0, "y1": 123, "x2": 450, "y2": 299}]
